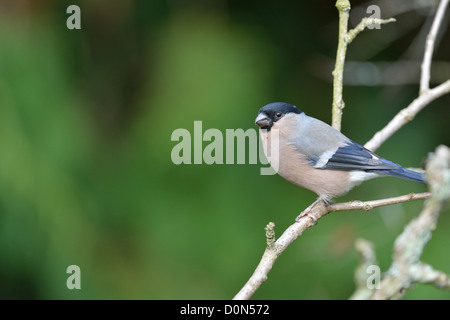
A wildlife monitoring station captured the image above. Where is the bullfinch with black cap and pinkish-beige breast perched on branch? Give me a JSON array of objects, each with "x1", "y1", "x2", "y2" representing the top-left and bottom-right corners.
[{"x1": 255, "y1": 102, "x2": 425, "y2": 220}]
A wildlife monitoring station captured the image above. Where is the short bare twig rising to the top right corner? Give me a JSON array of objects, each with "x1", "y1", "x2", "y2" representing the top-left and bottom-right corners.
[{"x1": 419, "y1": 0, "x2": 449, "y2": 95}]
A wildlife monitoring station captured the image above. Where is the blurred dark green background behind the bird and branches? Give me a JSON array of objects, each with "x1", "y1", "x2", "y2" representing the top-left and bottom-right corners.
[{"x1": 0, "y1": 0, "x2": 450, "y2": 299}]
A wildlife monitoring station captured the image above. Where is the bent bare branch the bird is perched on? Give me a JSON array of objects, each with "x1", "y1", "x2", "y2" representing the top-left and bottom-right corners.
[{"x1": 234, "y1": 192, "x2": 430, "y2": 300}]
